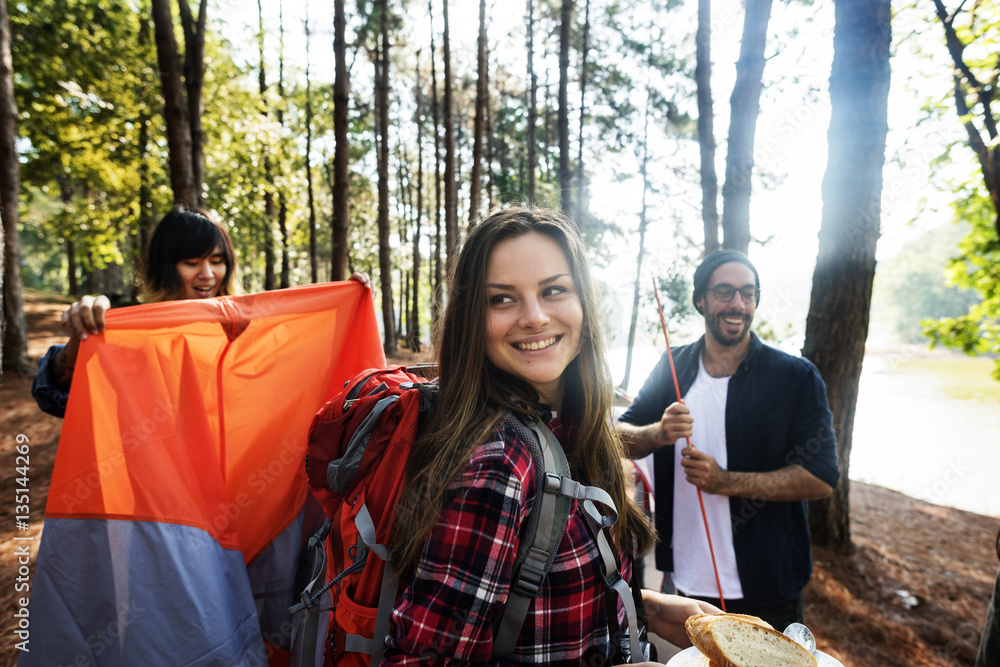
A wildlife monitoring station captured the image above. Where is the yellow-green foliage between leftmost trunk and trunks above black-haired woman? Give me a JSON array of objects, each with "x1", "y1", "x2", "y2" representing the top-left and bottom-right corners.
[{"x1": 11, "y1": 0, "x2": 163, "y2": 287}]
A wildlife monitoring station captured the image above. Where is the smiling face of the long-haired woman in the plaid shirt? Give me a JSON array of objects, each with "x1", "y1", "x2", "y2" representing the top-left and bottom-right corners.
[{"x1": 486, "y1": 232, "x2": 583, "y2": 409}]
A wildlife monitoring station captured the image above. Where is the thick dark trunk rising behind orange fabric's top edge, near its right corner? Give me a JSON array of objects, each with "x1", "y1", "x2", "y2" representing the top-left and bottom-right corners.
[{"x1": 330, "y1": 0, "x2": 351, "y2": 280}]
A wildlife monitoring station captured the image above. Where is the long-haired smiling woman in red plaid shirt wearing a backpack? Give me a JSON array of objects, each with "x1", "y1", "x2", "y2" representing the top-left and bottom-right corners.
[{"x1": 385, "y1": 208, "x2": 717, "y2": 665}]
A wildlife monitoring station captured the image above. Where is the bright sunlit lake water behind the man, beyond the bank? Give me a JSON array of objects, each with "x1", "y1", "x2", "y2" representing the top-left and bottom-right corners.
[{"x1": 611, "y1": 346, "x2": 1000, "y2": 515}]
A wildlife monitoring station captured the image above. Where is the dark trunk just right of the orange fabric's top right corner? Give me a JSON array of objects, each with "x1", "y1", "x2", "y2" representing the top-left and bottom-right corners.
[{"x1": 375, "y1": 0, "x2": 396, "y2": 354}]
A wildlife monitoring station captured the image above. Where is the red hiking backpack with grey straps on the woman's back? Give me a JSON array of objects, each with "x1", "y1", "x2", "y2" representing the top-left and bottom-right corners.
[{"x1": 289, "y1": 366, "x2": 649, "y2": 667}]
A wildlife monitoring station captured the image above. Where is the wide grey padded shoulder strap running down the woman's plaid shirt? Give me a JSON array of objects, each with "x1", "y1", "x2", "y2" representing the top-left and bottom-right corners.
[{"x1": 493, "y1": 417, "x2": 570, "y2": 660}]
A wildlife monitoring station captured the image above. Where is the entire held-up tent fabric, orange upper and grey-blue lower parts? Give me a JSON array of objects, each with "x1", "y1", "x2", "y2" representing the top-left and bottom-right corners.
[{"x1": 21, "y1": 282, "x2": 385, "y2": 665}]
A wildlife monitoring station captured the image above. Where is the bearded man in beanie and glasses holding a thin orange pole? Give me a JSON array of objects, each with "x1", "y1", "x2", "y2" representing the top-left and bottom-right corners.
[{"x1": 617, "y1": 250, "x2": 840, "y2": 630}]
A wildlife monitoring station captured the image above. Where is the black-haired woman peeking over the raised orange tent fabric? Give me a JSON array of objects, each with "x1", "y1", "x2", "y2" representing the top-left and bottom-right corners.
[{"x1": 31, "y1": 208, "x2": 240, "y2": 417}]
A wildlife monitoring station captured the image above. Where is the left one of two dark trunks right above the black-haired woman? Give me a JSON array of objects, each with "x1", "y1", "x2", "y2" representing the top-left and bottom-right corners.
[{"x1": 151, "y1": 0, "x2": 198, "y2": 207}]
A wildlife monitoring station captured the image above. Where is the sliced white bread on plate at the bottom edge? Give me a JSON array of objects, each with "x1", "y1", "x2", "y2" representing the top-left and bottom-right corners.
[{"x1": 684, "y1": 614, "x2": 816, "y2": 667}]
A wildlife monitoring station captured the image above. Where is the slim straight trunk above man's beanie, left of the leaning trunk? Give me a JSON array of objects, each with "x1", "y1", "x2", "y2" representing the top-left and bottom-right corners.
[{"x1": 694, "y1": 0, "x2": 719, "y2": 255}]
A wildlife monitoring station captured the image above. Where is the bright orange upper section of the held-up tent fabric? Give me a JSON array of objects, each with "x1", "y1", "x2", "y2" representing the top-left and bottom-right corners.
[{"x1": 46, "y1": 282, "x2": 385, "y2": 562}]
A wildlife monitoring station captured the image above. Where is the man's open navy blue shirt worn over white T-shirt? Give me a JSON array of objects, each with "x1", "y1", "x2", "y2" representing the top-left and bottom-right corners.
[{"x1": 620, "y1": 332, "x2": 840, "y2": 606}]
